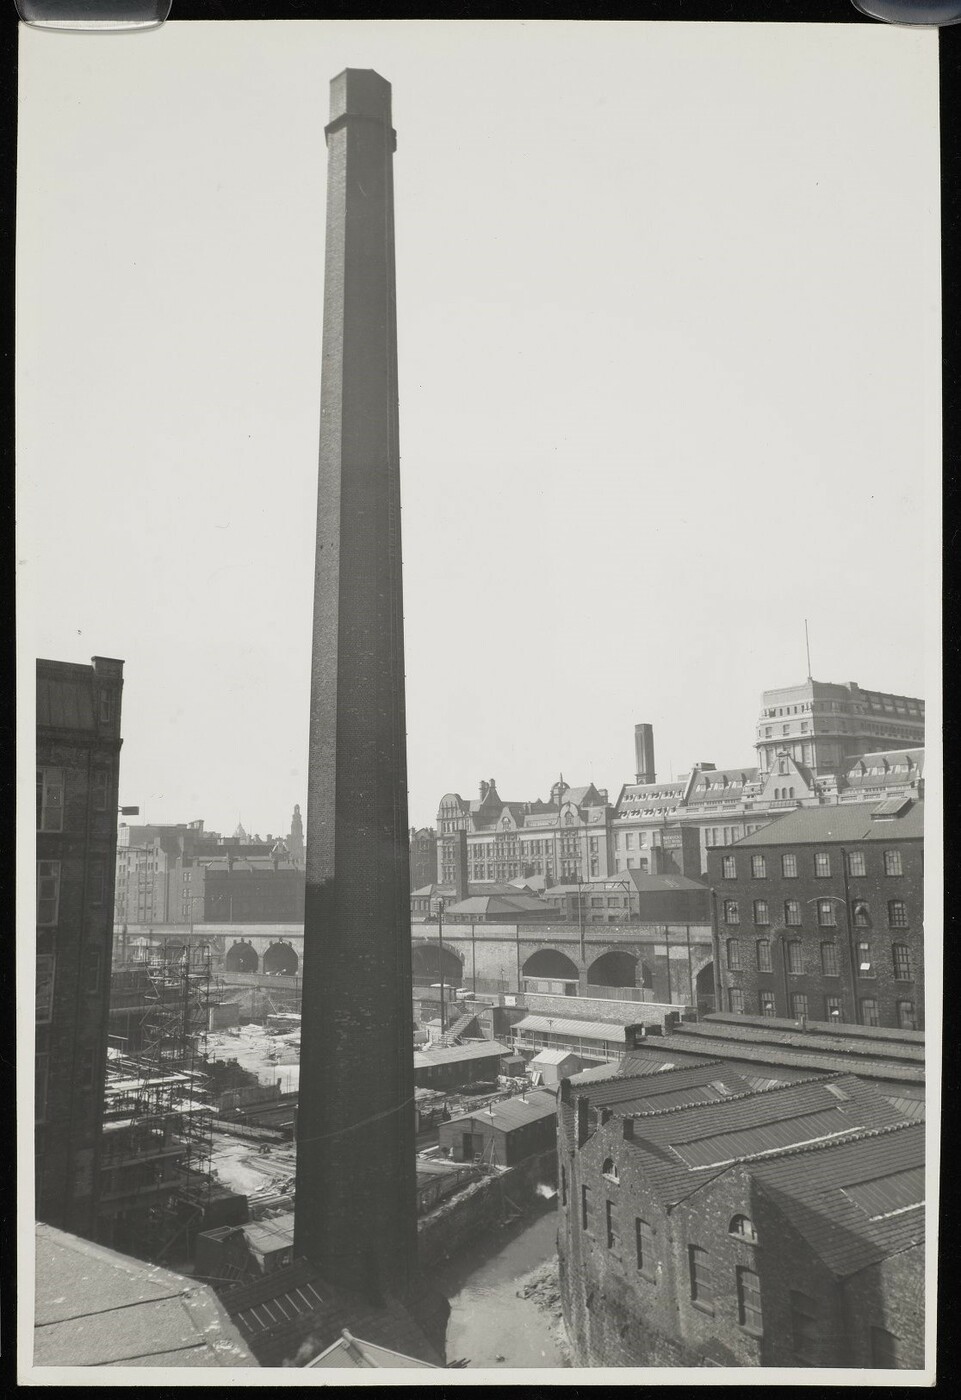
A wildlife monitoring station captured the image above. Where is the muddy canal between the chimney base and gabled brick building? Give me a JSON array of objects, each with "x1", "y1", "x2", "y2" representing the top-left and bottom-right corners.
[{"x1": 434, "y1": 1205, "x2": 569, "y2": 1369}]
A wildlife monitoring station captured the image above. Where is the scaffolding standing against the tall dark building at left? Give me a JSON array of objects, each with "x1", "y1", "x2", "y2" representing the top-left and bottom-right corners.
[{"x1": 101, "y1": 939, "x2": 217, "y2": 1260}]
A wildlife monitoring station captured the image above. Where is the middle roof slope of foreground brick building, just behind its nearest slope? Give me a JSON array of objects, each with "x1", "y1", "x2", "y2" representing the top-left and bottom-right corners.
[{"x1": 613, "y1": 1075, "x2": 905, "y2": 1204}]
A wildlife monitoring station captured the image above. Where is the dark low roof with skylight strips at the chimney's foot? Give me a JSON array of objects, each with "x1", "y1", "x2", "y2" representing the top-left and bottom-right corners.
[{"x1": 221, "y1": 1259, "x2": 443, "y2": 1366}]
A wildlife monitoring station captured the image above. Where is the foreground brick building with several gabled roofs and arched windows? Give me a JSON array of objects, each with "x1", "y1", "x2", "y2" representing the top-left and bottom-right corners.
[{"x1": 558, "y1": 1065, "x2": 925, "y2": 1369}]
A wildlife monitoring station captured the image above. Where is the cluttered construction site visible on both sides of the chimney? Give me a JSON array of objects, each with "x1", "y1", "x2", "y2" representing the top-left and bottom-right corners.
[{"x1": 99, "y1": 939, "x2": 553, "y2": 1285}]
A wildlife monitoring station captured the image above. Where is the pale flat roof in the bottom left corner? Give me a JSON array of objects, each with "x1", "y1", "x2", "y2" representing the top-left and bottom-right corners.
[{"x1": 34, "y1": 1225, "x2": 256, "y2": 1366}]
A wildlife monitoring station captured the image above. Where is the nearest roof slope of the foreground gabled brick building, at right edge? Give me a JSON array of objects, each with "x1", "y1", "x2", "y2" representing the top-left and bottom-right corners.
[{"x1": 751, "y1": 1123, "x2": 925, "y2": 1277}]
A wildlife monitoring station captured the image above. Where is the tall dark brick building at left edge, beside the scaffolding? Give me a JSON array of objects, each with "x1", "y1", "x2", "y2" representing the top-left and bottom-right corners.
[{"x1": 35, "y1": 657, "x2": 123, "y2": 1235}]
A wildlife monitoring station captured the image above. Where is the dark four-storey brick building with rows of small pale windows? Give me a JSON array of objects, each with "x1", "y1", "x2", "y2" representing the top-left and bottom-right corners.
[{"x1": 709, "y1": 798, "x2": 925, "y2": 1029}]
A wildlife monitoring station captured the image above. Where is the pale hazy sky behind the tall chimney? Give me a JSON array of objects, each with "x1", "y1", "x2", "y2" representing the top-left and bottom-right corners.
[{"x1": 18, "y1": 21, "x2": 939, "y2": 834}]
